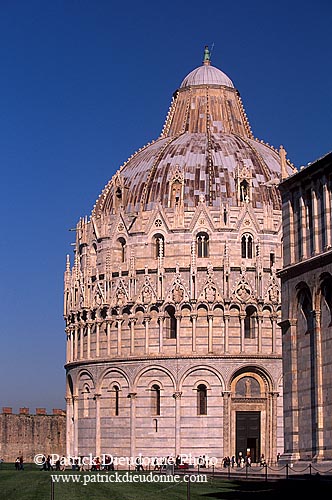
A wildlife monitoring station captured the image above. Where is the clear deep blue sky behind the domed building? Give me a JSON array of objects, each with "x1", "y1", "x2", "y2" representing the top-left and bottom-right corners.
[{"x1": 0, "y1": 0, "x2": 332, "y2": 412}]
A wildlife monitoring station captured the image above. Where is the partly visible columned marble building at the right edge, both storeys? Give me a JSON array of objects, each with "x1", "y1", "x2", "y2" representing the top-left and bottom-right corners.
[{"x1": 280, "y1": 153, "x2": 332, "y2": 461}]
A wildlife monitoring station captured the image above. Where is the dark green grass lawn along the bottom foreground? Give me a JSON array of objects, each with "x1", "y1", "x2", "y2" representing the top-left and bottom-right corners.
[{"x1": 0, "y1": 464, "x2": 332, "y2": 500}]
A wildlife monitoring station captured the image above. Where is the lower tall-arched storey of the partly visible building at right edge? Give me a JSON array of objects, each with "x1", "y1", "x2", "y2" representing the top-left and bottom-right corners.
[{"x1": 283, "y1": 259, "x2": 332, "y2": 460}]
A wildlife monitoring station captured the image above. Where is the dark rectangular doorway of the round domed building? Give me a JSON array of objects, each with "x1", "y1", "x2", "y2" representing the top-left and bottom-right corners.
[{"x1": 236, "y1": 411, "x2": 261, "y2": 462}]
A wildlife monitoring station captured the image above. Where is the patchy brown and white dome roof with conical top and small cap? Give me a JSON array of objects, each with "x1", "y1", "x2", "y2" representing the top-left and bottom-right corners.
[{"x1": 93, "y1": 48, "x2": 295, "y2": 218}]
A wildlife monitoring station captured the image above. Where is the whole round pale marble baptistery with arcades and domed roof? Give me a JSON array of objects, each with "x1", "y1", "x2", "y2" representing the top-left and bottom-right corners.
[{"x1": 64, "y1": 47, "x2": 295, "y2": 461}]
